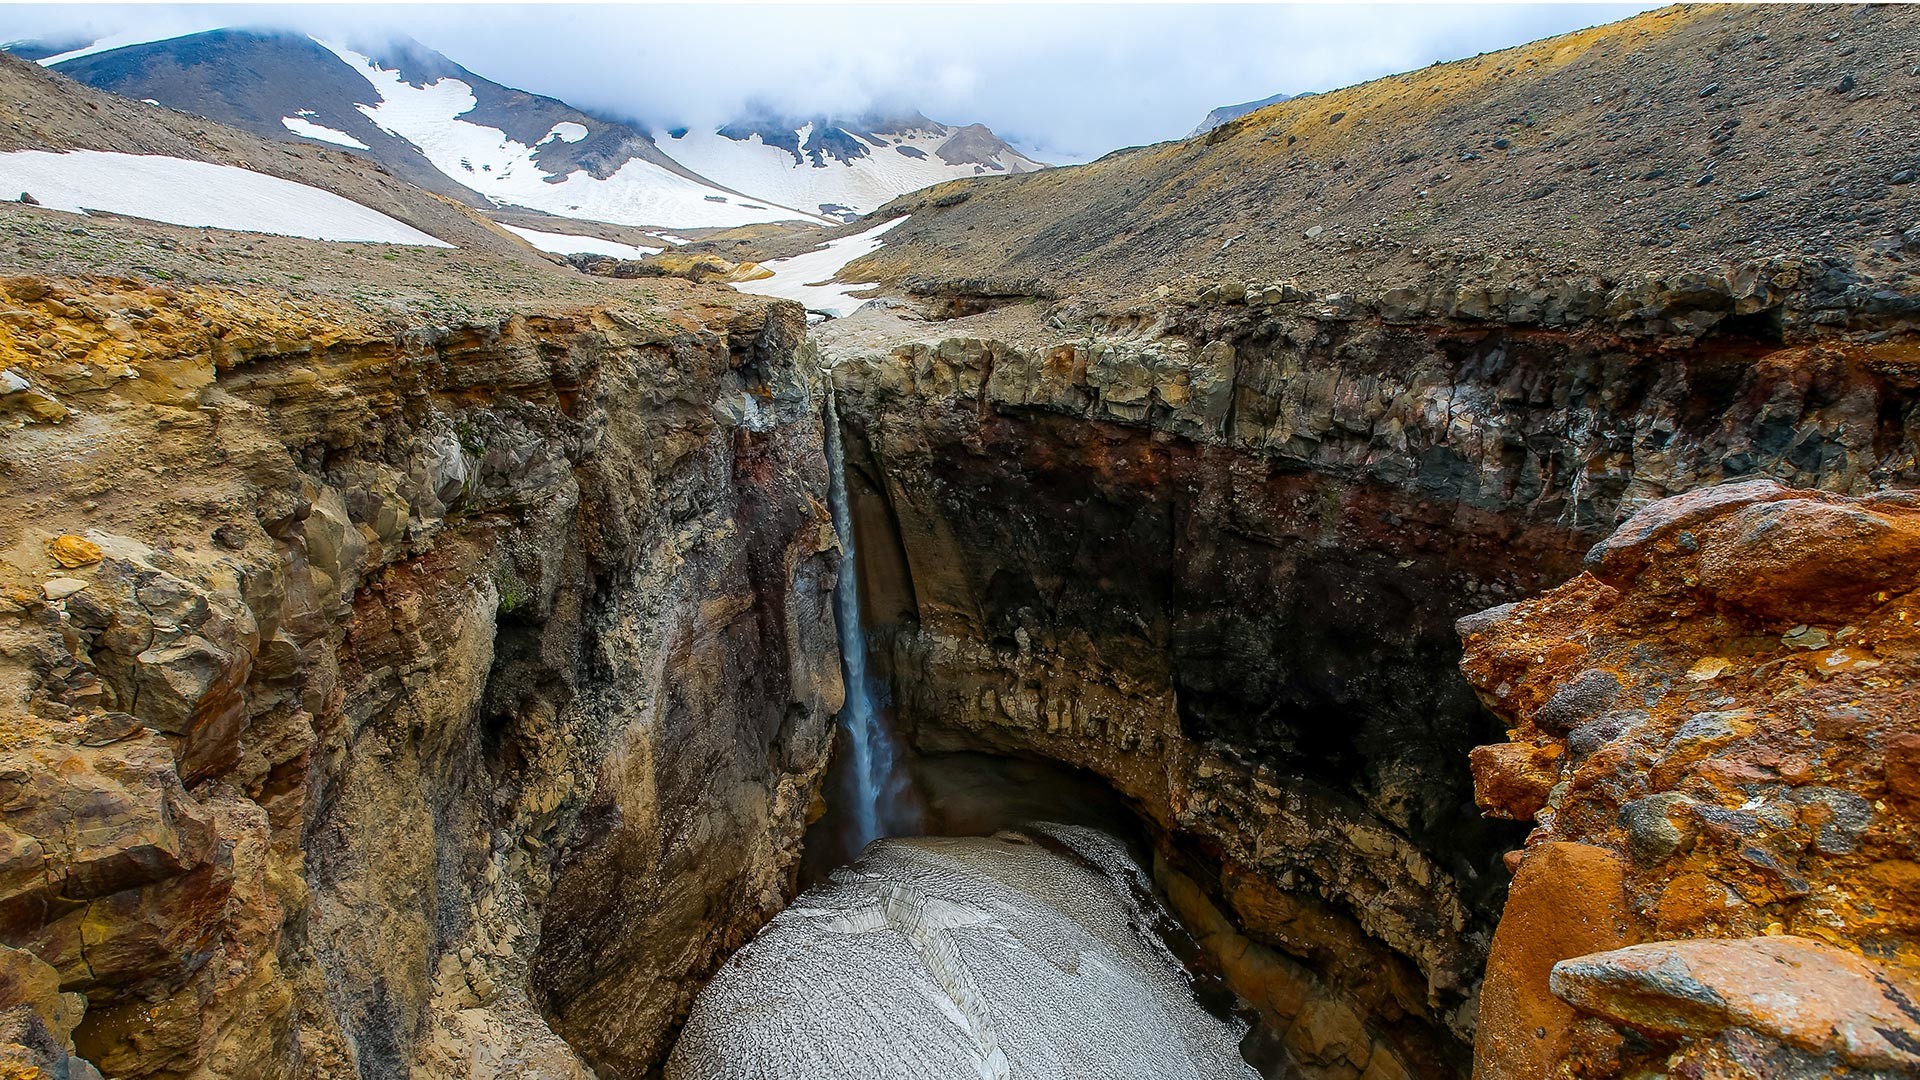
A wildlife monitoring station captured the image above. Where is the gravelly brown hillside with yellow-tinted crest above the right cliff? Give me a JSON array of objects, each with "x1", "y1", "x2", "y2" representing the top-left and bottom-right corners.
[{"x1": 847, "y1": 6, "x2": 1920, "y2": 307}]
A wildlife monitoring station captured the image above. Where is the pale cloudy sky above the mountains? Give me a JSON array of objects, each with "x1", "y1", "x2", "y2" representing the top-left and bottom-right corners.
[{"x1": 0, "y1": 4, "x2": 1655, "y2": 163}]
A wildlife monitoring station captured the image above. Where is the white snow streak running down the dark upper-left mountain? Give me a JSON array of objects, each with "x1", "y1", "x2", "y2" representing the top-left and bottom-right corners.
[{"x1": 319, "y1": 40, "x2": 818, "y2": 229}]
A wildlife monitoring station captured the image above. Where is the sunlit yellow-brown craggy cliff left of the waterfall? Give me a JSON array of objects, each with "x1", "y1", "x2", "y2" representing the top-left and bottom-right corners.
[{"x1": 0, "y1": 279, "x2": 841, "y2": 1078}]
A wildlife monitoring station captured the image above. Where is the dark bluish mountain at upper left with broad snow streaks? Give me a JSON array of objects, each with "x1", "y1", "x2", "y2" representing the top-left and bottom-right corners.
[{"x1": 45, "y1": 29, "x2": 825, "y2": 227}]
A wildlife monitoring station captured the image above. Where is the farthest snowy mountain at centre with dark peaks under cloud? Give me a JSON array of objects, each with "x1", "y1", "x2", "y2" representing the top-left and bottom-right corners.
[{"x1": 660, "y1": 113, "x2": 1044, "y2": 219}]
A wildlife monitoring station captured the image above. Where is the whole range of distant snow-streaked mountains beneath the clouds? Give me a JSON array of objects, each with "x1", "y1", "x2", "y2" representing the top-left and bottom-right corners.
[{"x1": 30, "y1": 29, "x2": 1043, "y2": 229}]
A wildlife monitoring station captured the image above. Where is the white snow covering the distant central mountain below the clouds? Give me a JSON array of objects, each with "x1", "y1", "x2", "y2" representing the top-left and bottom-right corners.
[{"x1": 659, "y1": 125, "x2": 1041, "y2": 213}]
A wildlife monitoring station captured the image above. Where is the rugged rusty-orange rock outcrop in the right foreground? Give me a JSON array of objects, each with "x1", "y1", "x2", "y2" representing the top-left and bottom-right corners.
[{"x1": 1461, "y1": 480, "x2": 1920, "y2": 1076}]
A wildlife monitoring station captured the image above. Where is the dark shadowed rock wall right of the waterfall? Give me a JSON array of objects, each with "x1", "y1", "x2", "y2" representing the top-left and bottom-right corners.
[{"x1": 824, "y1": 294, "x2": 1916, "y2": 1076}]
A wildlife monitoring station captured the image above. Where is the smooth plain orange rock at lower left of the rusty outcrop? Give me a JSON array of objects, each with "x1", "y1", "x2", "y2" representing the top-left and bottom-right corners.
[{"x1": 1473, "y1": 842, "x2": 1632, "y2": 1078}]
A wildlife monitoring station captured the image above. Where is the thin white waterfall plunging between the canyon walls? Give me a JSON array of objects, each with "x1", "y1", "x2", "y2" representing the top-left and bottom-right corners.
[{"x1": 826, "y1": 384, "x2": 920, "y2": 855}]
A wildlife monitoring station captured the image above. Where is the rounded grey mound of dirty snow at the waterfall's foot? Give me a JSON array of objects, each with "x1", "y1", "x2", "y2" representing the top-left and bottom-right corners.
[{"x1": 666, "y1": 824, "x2": 1258, "y2": 1080}]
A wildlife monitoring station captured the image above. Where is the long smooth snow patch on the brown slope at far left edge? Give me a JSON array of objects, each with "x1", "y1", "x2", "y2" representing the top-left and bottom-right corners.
[{"x1": 0, "y1": 150, "x2": 453, "y2": 248}]
